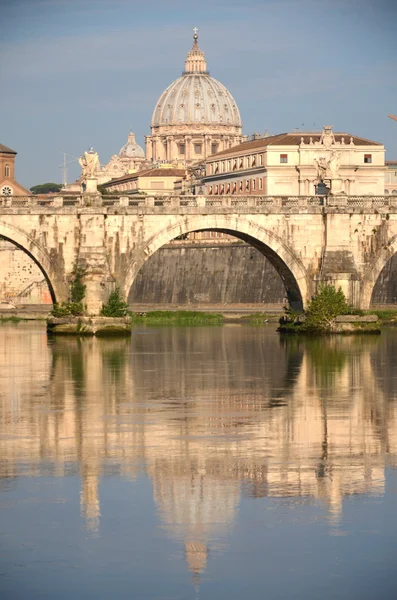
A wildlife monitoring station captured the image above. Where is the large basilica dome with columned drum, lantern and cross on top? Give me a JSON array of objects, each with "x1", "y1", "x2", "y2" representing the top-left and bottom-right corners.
[{"x1": 146, "y1": 33, "x2": 243, "y2": 164}]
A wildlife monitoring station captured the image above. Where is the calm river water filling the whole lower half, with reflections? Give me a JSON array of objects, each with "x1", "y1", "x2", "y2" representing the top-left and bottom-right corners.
[{"x1": 0, "y1": 323, "x2": 397, "y2": 600}]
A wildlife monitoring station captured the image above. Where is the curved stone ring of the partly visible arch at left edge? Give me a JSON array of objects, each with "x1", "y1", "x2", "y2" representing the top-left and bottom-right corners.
[{"x1": 0, "y1": 221, "x2": 64, "y2": 303}]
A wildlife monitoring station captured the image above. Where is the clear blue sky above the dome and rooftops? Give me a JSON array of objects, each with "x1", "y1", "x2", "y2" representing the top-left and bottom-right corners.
[{"x1": 0, "y1": 0, "x2": 397, "y2": 187}]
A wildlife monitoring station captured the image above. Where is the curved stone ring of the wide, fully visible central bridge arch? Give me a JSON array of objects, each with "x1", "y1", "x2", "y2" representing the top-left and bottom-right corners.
[{"x1": 121, "y1": 215, "x2": 312, "y2": 310}]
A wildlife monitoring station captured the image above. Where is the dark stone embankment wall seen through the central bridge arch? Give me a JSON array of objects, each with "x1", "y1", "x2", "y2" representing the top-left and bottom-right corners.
[{"x1": 128, "y1": 242, "x2": 285, "y2": 304}]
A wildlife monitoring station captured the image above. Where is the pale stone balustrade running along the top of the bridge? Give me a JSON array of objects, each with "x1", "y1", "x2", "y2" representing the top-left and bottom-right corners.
[{"x1": 0, "y1": 194, "x2": 397, "y2": 213}]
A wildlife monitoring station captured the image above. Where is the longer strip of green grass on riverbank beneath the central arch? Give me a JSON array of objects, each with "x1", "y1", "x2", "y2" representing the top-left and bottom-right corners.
[{"x1": 131, "y1": 310, "x2": 225, "y2": 326}]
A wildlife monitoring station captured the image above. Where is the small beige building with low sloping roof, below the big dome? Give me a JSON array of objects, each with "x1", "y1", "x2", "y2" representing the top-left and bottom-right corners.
[{"x1": 103, "y1": 165, "x2": 186, "y2": 196}]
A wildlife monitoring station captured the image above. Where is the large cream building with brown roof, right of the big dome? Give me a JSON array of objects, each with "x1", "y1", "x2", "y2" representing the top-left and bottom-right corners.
[{"x1": 203, "y1": 127, "x2": 385, "y2": 196}]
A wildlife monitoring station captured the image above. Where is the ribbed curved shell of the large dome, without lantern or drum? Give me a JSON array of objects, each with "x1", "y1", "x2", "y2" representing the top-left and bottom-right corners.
[{"x1": 152, "y1": 72, "x2": 241, "y2": 127}]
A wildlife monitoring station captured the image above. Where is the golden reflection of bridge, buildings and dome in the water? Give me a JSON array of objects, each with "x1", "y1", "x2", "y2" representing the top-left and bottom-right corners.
[{"x1": 0, "y1": 326, "x2": 397, "y2": 577}]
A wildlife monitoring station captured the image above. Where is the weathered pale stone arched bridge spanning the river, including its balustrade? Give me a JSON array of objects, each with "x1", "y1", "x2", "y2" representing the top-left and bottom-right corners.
[{"x1": 0, "y1": 194, "x2": 397, "y2": 314}]
